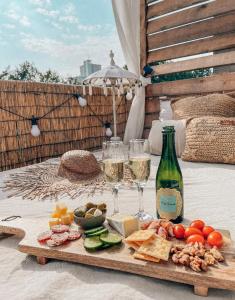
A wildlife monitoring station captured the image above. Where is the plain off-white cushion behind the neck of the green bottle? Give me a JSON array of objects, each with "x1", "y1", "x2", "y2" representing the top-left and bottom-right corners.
[{"x1": 149, "y1": 120, "x2": 186, "y2": 157}]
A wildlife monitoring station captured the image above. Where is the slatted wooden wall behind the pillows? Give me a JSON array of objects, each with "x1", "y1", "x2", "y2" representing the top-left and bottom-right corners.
[{"x1": 140, "y1": 0, "x2": 235, "y2": 136}]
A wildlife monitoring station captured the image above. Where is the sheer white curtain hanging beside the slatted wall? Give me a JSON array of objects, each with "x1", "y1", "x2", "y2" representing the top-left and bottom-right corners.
[{"x1": 112, "y1": 0, "x2": 145, "y2": 144}]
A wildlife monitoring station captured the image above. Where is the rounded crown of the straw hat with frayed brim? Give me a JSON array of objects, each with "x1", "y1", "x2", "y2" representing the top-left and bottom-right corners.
[{"x1": 58, "y1": 150, "x2": 101, "y2": 181}]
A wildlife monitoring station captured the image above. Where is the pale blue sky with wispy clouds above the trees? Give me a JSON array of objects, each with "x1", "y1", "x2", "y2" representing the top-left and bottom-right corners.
[{"x1": 0, "y1": 0, "x2": 125, "y2": 76}]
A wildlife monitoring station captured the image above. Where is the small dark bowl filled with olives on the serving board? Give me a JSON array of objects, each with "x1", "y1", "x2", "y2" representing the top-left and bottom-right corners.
[{"x1": 74, "y1": 202, "x2": 107, "y2": 229}]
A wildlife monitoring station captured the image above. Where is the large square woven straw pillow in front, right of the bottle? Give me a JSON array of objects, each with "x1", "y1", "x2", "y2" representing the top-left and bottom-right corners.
[{"x1": 181, "y1": 117, "x2": 235, "y2": 164}]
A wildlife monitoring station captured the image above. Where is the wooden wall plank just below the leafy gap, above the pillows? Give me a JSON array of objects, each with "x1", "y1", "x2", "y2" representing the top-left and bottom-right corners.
[{"x1": 146, "y1": 72, "x2": 235, "y2": 97}]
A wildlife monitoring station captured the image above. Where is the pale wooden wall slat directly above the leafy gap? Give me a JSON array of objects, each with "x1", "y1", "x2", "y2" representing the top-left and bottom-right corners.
[{"x1": 153, "y1": 51, "x2": 235, "y2": 75}]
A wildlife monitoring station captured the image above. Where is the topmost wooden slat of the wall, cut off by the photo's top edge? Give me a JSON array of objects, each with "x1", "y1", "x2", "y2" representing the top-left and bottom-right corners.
[{"x1": 147, "y1": 0, "x2": 205, "y2": 19}]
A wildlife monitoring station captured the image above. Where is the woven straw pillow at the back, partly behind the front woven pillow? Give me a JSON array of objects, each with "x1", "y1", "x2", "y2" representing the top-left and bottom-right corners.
[{"x1": 171, "y1": 94, "x2": 235, "y2": 120}]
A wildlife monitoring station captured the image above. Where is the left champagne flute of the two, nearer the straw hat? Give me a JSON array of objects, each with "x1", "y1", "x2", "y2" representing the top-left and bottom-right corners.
[{"x1": 102, "y1": 141, "x2": 125, "y2": 215}]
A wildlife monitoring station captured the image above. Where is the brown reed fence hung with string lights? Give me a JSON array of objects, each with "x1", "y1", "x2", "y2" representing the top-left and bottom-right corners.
[{"x1": 0, "y1": 81, "x2": 129, "y2": 170}]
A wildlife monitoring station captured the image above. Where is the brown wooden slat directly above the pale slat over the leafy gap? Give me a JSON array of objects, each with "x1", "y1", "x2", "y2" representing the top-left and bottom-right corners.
[{"x1": 147, "y1": 31, "x2": 235, "y2": 63}]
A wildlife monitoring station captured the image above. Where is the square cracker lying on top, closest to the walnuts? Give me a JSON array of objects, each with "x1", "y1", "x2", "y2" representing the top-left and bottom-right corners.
[{"x1": 138, "y1": 235, "x2": 172, "y2": 261}]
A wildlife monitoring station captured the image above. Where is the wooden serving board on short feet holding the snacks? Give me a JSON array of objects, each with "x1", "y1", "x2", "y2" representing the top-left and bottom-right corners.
[{"x1": 0, "y1": 218, "x2": 235, "y2": 296}]
